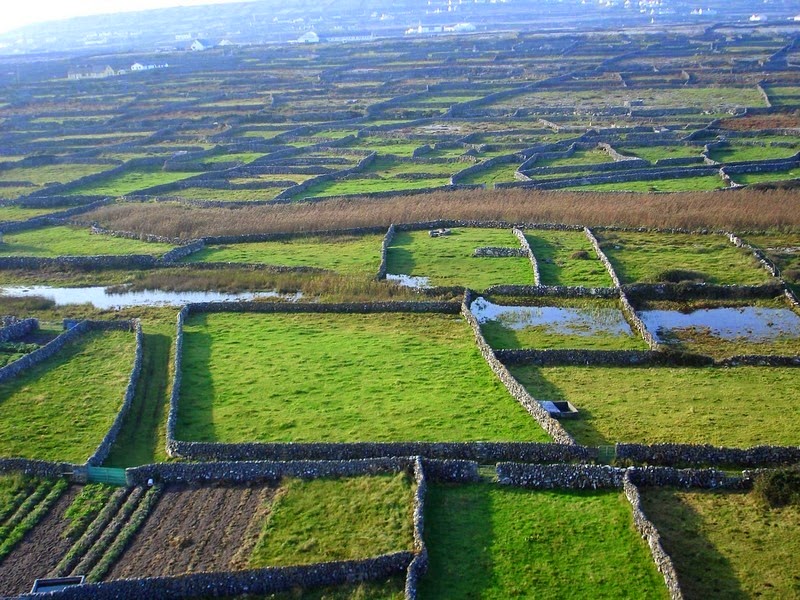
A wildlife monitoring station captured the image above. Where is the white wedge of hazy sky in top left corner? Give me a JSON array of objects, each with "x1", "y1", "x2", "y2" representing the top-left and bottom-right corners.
[{"x1": 0, "y1": 0, "x2": 256, "y2": 32}]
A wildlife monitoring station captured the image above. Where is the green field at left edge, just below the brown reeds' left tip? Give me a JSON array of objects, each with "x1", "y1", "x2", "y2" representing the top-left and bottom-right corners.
[{"x1": 0, "y1": 225, "x2": 172, "y2": 257}]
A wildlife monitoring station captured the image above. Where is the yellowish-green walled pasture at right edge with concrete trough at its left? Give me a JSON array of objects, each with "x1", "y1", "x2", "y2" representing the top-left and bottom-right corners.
[{"x1": 512, "y1": 367, "x2": 800, "y2": 447}]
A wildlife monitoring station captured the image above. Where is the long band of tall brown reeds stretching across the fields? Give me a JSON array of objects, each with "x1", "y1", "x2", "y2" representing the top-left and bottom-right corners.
[{"x1": 85, "y1": 189, "x2": 800, "y2": 239}]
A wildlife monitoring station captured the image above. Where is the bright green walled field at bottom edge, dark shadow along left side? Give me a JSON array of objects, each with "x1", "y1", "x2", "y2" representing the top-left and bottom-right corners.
[{"x1": 420, "y1": 484, "x2": 668, "y2": 600}]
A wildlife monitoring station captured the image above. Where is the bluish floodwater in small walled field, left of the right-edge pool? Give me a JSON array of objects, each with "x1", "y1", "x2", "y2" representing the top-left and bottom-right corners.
[{"x1": 470, "y1": 298, "x2": 633, "y2": 336}]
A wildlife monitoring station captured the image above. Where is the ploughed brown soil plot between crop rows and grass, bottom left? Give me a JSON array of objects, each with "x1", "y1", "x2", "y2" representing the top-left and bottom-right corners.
[{"x1": 106, "y1": 485, "x2": 277, "y2": 580}]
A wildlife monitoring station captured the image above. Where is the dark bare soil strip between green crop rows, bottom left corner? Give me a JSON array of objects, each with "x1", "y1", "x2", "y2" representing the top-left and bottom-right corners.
[{"x1": 0, "y1": 485, "x2": 82, "y2": 595}]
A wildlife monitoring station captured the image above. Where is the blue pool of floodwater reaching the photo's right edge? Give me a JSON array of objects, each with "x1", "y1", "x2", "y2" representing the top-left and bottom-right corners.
[{"x1": 639, "y1": 306, "x2": 800, "y2": 342}]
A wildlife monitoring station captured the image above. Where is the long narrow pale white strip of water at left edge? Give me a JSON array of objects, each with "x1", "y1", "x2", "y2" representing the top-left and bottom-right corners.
[{"x1": 0, "y1": 285, "x2": 301, "y2": 309}]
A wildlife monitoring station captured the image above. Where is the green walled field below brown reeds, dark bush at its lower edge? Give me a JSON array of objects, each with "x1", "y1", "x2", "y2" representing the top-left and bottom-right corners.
[{"x1": 598, "y1": 231, "x2": 769, "y2": 284}]
